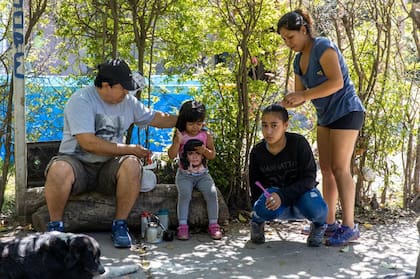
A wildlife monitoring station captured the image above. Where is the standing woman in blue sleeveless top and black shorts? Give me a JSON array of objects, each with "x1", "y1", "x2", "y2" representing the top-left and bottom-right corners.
[{"x1": 277, "y1": 9, "x2": 365, "y2": 246}]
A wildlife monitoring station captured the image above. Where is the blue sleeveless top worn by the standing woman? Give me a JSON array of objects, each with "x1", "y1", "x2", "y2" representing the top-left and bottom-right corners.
[{"x1": 293, "y1": 37, "x2": 365, "y2": 126}]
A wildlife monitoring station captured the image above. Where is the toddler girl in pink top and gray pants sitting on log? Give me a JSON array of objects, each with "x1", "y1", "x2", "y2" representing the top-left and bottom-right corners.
[{"x1": 168, "y1": 101, "x2": 222, "y2": 240}]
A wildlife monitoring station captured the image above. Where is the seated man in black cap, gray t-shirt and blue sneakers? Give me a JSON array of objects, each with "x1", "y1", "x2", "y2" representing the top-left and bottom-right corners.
[{"x1": 45, "y1": 59, "x2": 177, "y2": 248}]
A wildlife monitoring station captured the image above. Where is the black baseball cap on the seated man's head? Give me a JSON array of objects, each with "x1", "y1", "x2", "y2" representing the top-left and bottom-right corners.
[{"x1": 98, "y1": 59, "x2": 141, "y2": 91}]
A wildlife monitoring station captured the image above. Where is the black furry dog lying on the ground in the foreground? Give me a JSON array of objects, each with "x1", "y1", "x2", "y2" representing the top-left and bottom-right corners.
[{"x1": 0, "y1": 232, "x2": 105, "y2": 279}]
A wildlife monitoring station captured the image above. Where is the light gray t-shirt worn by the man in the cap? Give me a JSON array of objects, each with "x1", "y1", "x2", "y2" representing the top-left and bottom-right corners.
[{"x1": 60, "y1": 86, "x2": 156, "y2": 163}]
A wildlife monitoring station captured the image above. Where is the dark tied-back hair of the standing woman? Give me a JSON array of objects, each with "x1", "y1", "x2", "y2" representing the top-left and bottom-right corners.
[{"x1": 277, "y1": 9, "x2": 313, "y2": 37}]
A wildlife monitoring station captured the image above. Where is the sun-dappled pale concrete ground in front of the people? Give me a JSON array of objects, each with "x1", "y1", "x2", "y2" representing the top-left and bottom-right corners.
[{"x1": 87, "y1": 220, "x2": 419, "y2": 279}]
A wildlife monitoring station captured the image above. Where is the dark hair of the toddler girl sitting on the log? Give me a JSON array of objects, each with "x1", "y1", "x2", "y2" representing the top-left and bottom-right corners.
[{"x1": 175, "y1": 100, "x2": 206, "y2": 132}]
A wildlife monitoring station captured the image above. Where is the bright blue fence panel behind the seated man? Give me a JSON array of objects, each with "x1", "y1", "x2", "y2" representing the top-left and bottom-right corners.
[{"x1": 0, "y1": 75, "x2": 201, "y2": 161}]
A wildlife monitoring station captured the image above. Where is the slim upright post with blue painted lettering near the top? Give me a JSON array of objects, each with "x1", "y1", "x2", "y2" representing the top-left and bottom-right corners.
[{"x1": 13, "y1": 0, "x2": 26, "y2": 217}]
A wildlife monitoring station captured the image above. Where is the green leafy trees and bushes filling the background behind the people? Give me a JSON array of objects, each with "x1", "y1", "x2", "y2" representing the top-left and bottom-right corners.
[{"x1": 0, "y1": 0, "x2": 420, "y2": 213}]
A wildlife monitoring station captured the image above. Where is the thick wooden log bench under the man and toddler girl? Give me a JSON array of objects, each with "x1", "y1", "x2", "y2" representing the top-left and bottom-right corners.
[{"x1": 25, "y1": 184, "x2": 229, "y2": 232}]
